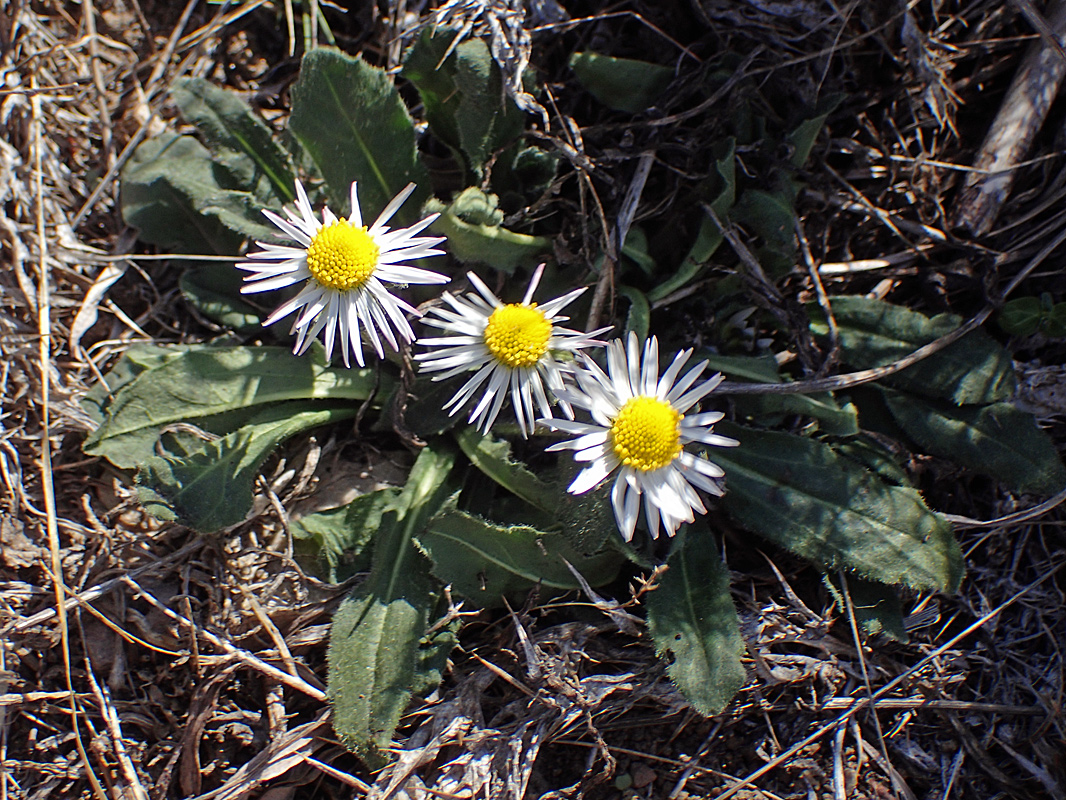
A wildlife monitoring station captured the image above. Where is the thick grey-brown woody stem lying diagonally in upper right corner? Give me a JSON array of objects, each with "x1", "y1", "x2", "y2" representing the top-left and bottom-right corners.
[{"x1": 952, "y1": 0, "x2": 1066, "y2": 237}]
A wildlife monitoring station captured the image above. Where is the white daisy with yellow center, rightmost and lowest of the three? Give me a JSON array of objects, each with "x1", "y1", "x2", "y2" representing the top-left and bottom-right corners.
[{"x1": 540, "y1": 333, "x2": 740, "y2": 542}]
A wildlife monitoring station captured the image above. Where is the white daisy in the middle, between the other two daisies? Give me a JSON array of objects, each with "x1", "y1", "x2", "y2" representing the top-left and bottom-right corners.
[{"x1": 415, "y1": 263, "x2": 611, "y2": 436}]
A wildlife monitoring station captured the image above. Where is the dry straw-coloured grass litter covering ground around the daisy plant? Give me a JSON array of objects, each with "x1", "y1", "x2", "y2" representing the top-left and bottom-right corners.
[{"x1": 0, "y1": 0, "x2": 1066, "y2": 800}]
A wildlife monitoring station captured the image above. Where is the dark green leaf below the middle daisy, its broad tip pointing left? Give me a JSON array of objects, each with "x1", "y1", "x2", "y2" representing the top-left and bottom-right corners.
[{"x1": 418, "y1": 509, "x2": 625, "y2": 607}]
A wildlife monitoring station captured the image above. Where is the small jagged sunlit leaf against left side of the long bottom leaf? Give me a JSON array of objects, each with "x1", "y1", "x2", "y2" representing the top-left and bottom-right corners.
[{"x1": 289, "y1": 486, "x2": 400, "y2": 583}]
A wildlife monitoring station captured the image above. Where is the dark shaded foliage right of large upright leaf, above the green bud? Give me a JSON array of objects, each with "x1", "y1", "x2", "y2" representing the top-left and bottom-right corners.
[{"x1": 403, "y1": 29, "x2": 523, "y2": 180}]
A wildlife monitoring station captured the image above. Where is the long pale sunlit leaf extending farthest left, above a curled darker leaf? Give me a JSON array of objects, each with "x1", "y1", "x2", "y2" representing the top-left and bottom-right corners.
[{"x1": 82, "y1": 346, "x2": 389, "y2": 468}]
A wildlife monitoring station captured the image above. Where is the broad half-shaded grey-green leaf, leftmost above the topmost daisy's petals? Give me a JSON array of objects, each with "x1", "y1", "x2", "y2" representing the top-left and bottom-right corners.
[{"x1": 122, "y1": 133, "x2": 275, "y2": 255}]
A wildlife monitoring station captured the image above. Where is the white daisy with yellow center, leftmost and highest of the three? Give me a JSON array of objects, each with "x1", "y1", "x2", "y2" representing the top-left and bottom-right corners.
[{"x1": 237, "y1": 180, "x2": 450, "y2": 367}]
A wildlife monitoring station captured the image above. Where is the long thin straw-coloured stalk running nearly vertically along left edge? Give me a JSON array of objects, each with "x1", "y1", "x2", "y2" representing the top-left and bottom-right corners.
[{"x1": 30, "y1": 75, "x2": 107, "y2": 800}]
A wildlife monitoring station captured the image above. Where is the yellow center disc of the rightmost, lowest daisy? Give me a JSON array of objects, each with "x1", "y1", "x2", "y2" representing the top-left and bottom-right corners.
[{"x1": 611, "y1": 395, "x2": 684, "y2": 473}]
